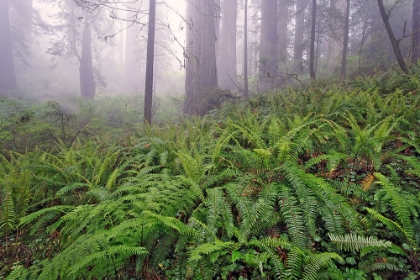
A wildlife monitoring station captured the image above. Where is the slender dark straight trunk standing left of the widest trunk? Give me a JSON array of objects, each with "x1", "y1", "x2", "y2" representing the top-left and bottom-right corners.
[{"x1": 144, "y1": 0, "x2": 156, "y2": 124}]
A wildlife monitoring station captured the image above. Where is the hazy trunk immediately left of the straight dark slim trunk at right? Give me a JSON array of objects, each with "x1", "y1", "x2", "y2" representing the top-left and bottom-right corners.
[{"x1": 293, "y1": 0, "x2": 306, "y2": 74}]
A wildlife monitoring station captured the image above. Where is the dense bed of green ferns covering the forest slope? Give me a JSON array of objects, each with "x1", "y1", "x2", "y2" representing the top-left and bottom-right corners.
[{"x1": 0, "y1": 72, "x2": 420, "y2": 280}]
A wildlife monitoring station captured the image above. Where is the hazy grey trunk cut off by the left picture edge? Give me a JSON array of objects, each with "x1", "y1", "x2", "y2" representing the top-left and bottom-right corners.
[{"x1": 0, "y1": 0, "x2": 17, "y2": 94}]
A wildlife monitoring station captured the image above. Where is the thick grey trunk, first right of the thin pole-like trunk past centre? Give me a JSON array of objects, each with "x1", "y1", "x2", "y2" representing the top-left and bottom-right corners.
[{"x1": 259, "y1": 0, "x2": 278, "y2": 90}]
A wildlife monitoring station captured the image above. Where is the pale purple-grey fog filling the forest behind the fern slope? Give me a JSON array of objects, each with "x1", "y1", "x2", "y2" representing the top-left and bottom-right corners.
[{"x1": 0, "y1": 0, "x2": 418, "y2": 114}]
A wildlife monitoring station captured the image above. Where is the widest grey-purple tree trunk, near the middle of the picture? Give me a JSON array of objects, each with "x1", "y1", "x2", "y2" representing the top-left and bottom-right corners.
[{"x1": 184, "y1": 0, "x2": 217, "y2": 114}]
